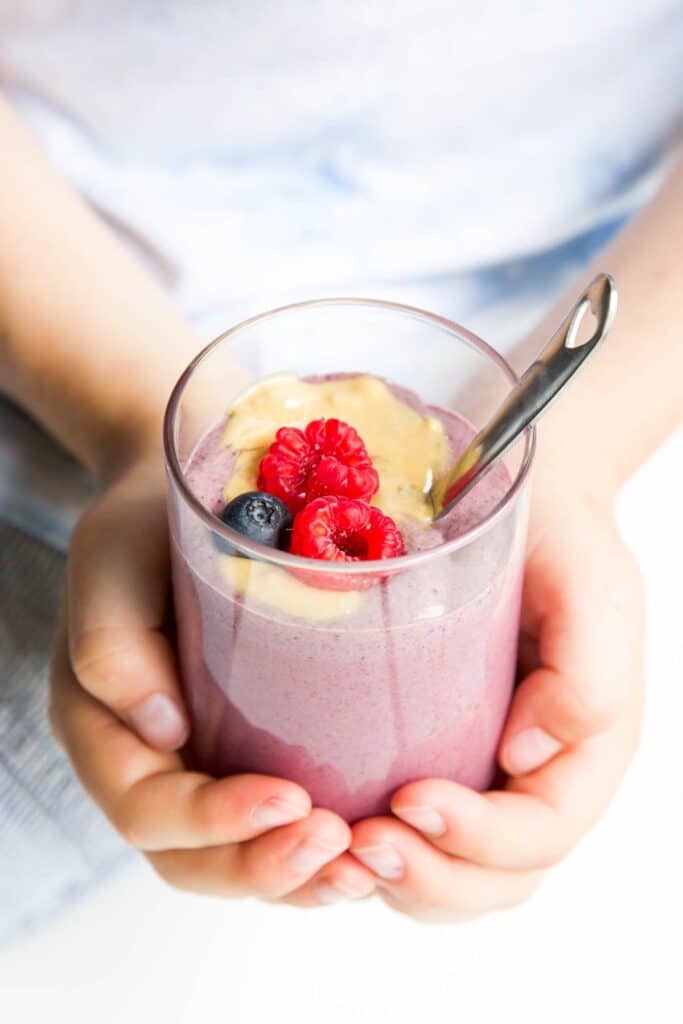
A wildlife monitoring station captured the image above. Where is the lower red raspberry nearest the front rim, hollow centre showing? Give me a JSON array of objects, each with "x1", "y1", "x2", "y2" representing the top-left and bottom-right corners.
[{"x1": 290, "y1": 496, "x2": 405, "y2": 590}]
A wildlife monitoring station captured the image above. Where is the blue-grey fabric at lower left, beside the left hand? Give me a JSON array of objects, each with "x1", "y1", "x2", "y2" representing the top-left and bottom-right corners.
[{"x1": 0, "y1": 522, "x2": 131, "y2": 944}]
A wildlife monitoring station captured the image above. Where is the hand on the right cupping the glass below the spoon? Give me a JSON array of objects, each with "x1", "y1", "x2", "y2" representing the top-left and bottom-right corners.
[{"x1": 351, "y1": 485, "x2": 643, "y2": 921}]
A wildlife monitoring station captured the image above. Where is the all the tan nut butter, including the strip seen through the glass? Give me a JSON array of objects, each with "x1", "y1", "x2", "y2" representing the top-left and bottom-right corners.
[{"x1": 219, "y1": 374, "x2": 449, "y2": 622}]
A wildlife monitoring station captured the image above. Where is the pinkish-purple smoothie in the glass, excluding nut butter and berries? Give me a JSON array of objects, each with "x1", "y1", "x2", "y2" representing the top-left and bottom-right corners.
[{"x1": 171, "y1": 378, "x2": 524, "y2": 821}]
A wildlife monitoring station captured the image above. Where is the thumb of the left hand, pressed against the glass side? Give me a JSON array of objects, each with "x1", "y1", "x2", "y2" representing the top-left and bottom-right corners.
[{"x1": 68, "y1": 468, "x2": 188, "y2": 750}]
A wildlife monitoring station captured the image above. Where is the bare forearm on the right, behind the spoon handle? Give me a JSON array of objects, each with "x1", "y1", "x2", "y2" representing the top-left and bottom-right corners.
[{"x1": 524, "y1": 147, "x2": 683, "y2": 499}]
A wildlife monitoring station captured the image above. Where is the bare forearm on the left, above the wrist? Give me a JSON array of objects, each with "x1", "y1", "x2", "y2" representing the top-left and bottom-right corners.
[{"x1": 0, "y1": 97, "x2": 201, "y2": 475}]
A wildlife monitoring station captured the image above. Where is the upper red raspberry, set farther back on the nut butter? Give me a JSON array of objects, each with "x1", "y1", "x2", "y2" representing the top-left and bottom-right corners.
[{"x1": 257, "y1": 419, "x2": 380, "y2": 513}]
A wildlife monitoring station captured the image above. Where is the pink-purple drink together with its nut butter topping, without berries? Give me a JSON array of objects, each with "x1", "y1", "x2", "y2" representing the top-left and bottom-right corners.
[{"x1": 166, "y1": 374, "x2": 524, "y2": 821}]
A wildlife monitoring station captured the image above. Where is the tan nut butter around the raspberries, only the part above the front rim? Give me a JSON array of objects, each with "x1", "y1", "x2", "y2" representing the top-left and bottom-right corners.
[{"x1": 223, "y1": 374, "x2": 449, "y2": 525}]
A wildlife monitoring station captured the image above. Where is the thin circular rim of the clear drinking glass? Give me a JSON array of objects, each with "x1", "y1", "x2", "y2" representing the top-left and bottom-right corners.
[{"x1": 163, "y1": 297, "x2": 536, "y2": 577}]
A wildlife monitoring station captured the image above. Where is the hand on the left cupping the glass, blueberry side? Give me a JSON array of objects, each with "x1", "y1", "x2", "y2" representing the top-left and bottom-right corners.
[{"x1": 50, "y1": 459, "x2": 375, "y2": 905}]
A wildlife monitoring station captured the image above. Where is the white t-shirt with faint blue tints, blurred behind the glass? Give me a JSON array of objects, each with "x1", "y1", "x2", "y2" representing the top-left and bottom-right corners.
[{"x1": 0, "y1": 0, "x2": 683, "y2": 312}]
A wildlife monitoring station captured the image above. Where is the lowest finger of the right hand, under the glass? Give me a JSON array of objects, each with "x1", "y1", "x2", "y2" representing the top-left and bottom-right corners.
[{"x1": 351, "y1": 818, "x2": 541, "y2": 913}]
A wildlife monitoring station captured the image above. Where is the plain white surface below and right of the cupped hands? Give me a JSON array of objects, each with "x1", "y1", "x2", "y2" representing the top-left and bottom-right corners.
[{"x1": 0, "y1": 434, "x2": 683, "y2": 1024}]
